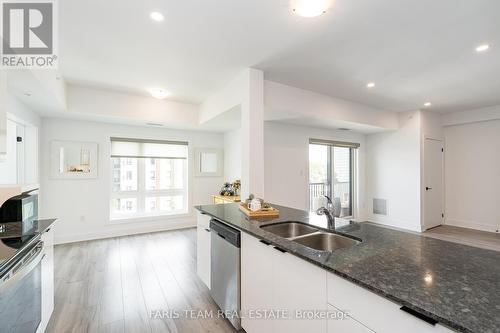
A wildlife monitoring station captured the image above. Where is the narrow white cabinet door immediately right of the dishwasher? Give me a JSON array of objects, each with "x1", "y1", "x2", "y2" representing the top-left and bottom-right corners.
[{"x1": 241, "y1": 233, "x2": 275, "y2": 333}]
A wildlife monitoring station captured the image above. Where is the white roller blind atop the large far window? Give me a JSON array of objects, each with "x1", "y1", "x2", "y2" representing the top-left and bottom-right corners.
[{"x1": 111, "y1": 138, "x2": 188, "y2": 159}]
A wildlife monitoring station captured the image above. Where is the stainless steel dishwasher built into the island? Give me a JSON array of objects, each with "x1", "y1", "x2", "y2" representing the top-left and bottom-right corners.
[{"x1": 210, "y1": 219, "x2": 241, "y2": 330}]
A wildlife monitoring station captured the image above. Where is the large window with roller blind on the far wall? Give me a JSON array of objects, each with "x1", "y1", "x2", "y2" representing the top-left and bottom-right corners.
[{"x1": 110, "y1": 138, "x2": 188, "y2": 219}]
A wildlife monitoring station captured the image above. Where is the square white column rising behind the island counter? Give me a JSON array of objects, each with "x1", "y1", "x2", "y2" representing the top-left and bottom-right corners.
[{"x1": 241, "y1": 68, "x2": 264, "y2": 199}]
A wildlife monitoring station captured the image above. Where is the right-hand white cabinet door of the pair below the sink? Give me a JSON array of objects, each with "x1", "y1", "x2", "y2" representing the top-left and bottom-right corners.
[{"x1": 273, "y1": 249, "x2": 327, "y2": 333}]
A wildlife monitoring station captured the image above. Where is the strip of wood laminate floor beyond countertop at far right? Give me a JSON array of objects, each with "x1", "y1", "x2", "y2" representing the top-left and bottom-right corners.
[{"x1": 423, "y1": 225, "x2": 500, "y2": 251}]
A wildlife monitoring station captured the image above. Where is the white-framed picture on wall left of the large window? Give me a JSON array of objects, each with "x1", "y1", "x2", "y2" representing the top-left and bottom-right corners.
[{"x1": 50, "y1": 141, "x2": 98, "y2": 179}]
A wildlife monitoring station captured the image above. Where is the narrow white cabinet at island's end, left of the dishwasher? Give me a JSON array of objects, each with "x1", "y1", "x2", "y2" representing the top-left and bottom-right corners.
[{"x1": 196, "y1": 212, "x2": 210, "y2": 289}]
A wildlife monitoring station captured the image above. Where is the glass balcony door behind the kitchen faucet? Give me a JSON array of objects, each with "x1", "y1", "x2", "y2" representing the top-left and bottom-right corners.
[{"x1": 309, "y1": 139, "x2": 359, "y2": 217}]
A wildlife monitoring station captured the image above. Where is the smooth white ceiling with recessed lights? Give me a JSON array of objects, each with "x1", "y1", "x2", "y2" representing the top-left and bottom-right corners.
[{"x1": 59, "y1": 0, "x2": 500, "y2": 112}]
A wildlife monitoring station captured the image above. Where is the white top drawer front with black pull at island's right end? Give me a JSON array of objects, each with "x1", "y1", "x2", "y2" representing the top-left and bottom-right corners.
[{"x1": 327, "y1": 273, "x2": 453, "y2": 333}]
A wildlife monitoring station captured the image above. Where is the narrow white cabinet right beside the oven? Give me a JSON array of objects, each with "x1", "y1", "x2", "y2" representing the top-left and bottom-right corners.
[{"x1": 37, "y1": 225, "x2": 54, "y2": 332}]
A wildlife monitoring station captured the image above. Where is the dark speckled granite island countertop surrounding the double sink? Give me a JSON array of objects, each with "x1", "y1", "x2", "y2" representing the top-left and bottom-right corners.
[{"x1": 196, "y1": 204, "x2": 500, "y2": 333}]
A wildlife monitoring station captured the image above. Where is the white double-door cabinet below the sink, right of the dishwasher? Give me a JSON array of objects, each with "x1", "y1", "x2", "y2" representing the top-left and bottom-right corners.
[{"x1": 241, "y1": 233, "x2": 327, "y2": 333}]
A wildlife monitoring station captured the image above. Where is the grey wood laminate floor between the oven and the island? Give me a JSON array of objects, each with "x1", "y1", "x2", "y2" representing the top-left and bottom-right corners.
[{"x1": 46, "y1": 229, "x2": 236, "y2": 333}]
